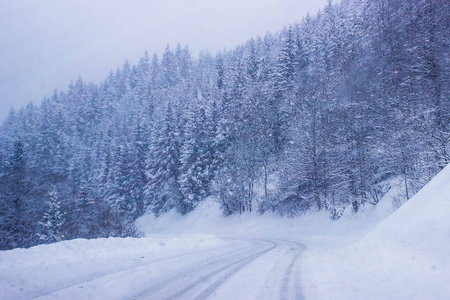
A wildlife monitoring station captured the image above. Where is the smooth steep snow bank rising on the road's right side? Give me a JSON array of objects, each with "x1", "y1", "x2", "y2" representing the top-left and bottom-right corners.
[{"x1": 303, "y1": 166, "x2": 450, "y2": 299}]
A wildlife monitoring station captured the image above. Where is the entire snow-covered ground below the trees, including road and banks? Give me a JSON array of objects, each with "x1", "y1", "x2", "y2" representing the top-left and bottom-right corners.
[{"x1": 0, "y1": 167, "x2": 450, "y2": 299}]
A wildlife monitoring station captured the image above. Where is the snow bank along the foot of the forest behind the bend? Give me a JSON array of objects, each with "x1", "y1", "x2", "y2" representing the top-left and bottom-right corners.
[{"x1": 137, "y1": 192, "x2": 394, "y2": 248}]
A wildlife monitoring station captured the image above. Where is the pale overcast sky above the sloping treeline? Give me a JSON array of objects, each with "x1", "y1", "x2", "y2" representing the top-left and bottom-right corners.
[{"x1": 0, "y1": 0, "x2": 327, "y2": 121}]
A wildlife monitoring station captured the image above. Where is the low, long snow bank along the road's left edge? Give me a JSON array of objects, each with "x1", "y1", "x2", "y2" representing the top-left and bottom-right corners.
[{"x1": 0, "y1": 235, "x2": 226, "y2": 299}]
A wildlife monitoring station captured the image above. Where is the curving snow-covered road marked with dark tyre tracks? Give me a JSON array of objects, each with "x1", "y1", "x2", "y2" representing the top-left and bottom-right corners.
[{"x1": 34, "y1": 239, "x2": 305, "y2": 300}]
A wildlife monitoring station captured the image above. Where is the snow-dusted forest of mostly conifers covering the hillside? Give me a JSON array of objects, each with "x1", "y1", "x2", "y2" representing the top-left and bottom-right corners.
[{"x1": 0, "y1": 0, "x2": 450, "y2": 249}]
